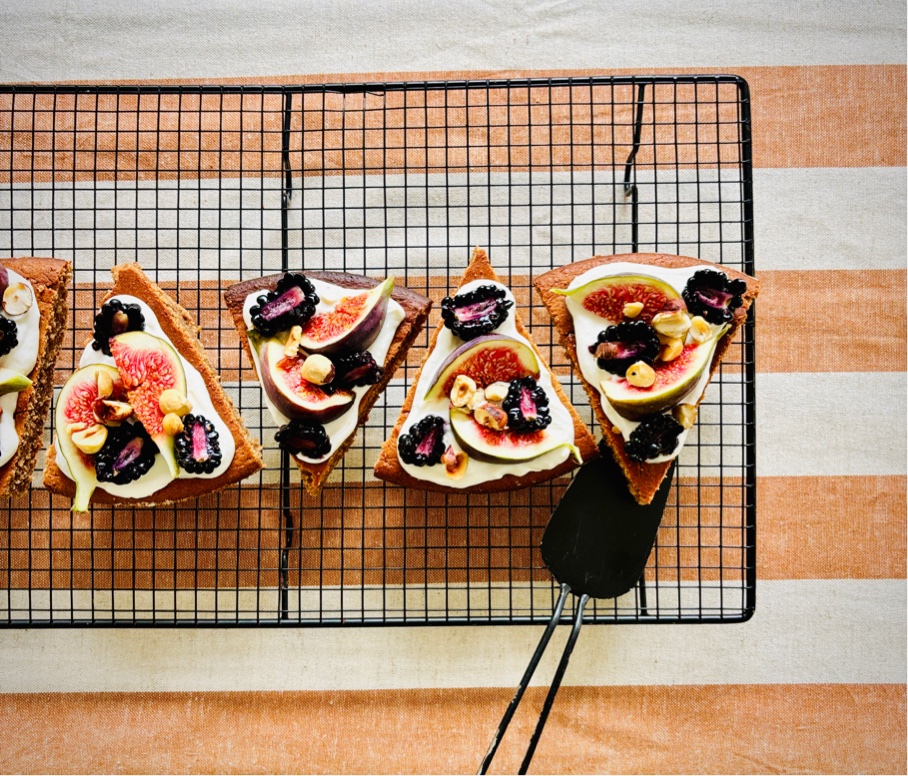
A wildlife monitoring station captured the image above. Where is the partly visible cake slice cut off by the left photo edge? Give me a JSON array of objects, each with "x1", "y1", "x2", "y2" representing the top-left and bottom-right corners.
[{"x1": 0, "y1": 257, "x2": 72, "y2": 496}]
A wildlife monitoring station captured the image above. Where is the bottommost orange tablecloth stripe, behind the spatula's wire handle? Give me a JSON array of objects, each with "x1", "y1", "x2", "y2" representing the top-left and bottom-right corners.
[{"x1": 0, "y1": 688, "x2": 906, "y2": 773}]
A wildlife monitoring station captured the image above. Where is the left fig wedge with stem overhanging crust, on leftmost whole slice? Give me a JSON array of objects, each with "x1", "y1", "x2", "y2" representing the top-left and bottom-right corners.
[{"x1": 54, "y1": 364, "x2": 125, "y2": 512}]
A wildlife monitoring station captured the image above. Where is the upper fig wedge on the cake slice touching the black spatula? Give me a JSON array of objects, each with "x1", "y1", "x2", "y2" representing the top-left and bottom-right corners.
[{"x1": 552, "y1": 275, "x2": 679, "y2": 323}]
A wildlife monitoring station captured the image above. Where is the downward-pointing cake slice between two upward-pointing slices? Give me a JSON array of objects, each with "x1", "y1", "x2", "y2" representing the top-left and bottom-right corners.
[{"x1": 224, "y1": 271, "x2": 432, "y2": 495}]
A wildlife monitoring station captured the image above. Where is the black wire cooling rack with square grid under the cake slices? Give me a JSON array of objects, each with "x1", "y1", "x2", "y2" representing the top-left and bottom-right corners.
[{"x1": 0, "y1": 76, "x2": 755, "y2": 626}]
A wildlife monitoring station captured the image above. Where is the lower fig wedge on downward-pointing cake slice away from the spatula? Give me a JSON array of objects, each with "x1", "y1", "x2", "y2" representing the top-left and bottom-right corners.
[{"x1": 259, "y1": 340, "x2": 355, "y2": 423}]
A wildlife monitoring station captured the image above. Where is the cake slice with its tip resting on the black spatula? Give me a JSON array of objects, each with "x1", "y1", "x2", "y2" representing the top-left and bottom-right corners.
[{"x1": 533, "y1": 253, "x2": 759, "y2": 504}]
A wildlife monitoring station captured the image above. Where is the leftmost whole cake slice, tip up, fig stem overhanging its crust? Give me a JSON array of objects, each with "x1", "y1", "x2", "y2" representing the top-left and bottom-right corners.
[{"x1": 44, "y1": 264, "x2": 263, "y2": 511}]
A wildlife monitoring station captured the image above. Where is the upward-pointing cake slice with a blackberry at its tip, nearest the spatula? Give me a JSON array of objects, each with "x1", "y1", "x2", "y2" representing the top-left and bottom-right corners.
[{"x1": 375, "y1": 248, "x2": 598, "y2": 493}]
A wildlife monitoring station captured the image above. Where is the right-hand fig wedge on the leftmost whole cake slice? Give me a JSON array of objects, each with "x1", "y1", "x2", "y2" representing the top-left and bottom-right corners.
[{"x1": 110, "y1": 331, "x2": 186, "y2": 477}]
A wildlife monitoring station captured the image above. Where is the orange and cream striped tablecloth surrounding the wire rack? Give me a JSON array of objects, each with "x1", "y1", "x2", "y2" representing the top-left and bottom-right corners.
[{"x1": 0, "y1": 0, "x2": 906, "y2": 773}]
